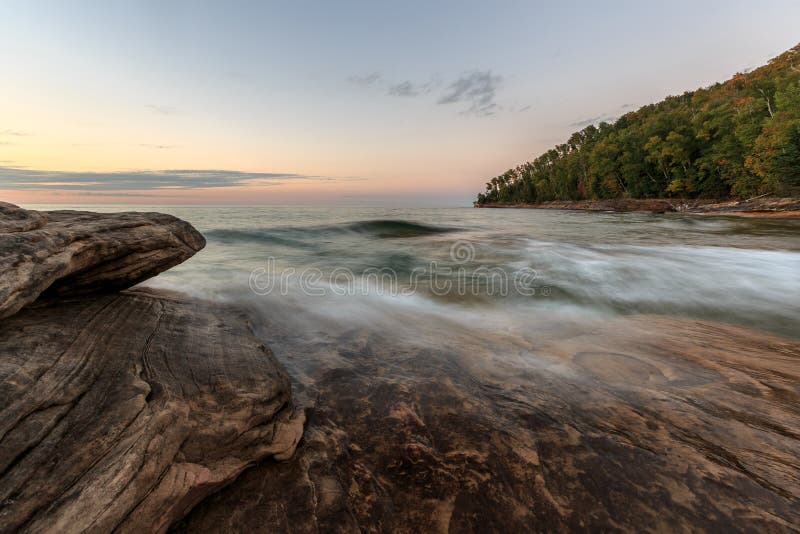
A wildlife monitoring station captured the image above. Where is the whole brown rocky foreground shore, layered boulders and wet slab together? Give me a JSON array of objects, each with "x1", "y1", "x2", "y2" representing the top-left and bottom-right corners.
[{"x1": 0, "y1": 203, "x2": 800, "y2": 534}]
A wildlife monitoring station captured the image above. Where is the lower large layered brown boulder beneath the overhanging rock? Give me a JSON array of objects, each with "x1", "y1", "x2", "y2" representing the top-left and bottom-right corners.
[{"x1": 0, "y1": 292, "x2": 304, "y2": 533}]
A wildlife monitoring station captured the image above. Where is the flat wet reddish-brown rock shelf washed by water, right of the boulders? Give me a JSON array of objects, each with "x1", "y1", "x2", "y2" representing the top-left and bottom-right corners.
[{"x1": 176, "y1": 316, "x2": 800, "y2": 532}]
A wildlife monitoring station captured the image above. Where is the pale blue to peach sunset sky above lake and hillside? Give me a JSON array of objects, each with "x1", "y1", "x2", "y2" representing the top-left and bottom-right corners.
[{"x1": 0, "y1": 0, "x2": 800, "y2": 206}]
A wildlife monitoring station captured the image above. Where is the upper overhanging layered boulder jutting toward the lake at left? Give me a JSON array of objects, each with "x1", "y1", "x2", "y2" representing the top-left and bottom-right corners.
[{"x1": 0, "y1": 202, "x2": 205, "y2": 318}]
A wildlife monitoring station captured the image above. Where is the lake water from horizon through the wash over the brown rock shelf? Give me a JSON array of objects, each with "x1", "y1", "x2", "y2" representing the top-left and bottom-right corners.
[{"x1": 23, "y1": 206, "x2": 800, "y2": 532}]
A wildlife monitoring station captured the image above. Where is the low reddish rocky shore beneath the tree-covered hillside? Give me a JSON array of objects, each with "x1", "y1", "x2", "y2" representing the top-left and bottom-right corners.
[{"x1": 473, "y1": 197, "x2": 800, "y2": 218}]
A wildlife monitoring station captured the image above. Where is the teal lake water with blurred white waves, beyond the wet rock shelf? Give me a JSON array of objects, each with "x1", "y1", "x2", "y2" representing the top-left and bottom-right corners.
[{"x1": 25, "y1": 206, "x2": 800, "y2": 343}]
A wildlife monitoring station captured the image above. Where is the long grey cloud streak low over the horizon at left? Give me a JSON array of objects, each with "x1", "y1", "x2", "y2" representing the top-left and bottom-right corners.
[{"x1": 0, "y1": 170, "x2": 350, "y2": 191}]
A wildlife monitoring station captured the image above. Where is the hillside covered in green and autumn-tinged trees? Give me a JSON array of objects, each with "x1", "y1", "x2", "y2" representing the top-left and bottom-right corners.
[{"x1": 477, "y1": 45, "x2": 800, "y2": 205}]
